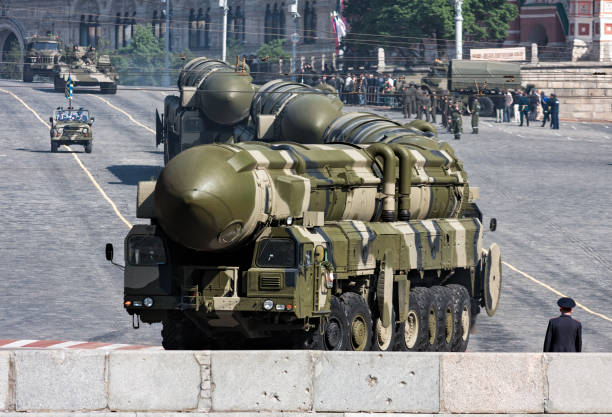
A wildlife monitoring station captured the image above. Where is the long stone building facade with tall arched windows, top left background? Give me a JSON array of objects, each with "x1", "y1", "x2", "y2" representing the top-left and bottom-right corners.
[{"x1": 0, "y1": 0, "x2": 341, "y2": 68}]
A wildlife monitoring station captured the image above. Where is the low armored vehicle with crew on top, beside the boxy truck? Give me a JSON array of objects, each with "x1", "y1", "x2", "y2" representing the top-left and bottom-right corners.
[{"x1": 53, "y1": 46, "x2": 119, "y2": 94}]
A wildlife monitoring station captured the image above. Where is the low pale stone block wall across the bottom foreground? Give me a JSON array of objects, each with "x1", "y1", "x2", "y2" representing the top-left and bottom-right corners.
[{"x1": 0, "y1": 350, "x2": 612, "y2": 417}]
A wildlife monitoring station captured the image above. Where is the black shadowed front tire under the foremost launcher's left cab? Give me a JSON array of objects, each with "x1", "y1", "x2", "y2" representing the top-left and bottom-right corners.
[{"x1": 161, "y1": 315, "x2": 210, "y2": 350}]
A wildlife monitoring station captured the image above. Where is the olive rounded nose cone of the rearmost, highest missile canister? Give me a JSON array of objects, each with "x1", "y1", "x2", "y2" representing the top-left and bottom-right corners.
[{"x1": 198, "y1": 71, "x2": 255, "y2": 125}]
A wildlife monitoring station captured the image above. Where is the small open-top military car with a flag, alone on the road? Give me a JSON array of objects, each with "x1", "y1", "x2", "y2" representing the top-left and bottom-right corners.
[{"x1": 49, "y1": 107, "x2": 94, "y2": 153}]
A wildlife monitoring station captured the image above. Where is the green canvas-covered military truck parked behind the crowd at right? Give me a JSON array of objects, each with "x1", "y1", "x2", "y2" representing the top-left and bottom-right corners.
[{"x1": 421, "y1": 59, "x2": 522, "y2": 116}]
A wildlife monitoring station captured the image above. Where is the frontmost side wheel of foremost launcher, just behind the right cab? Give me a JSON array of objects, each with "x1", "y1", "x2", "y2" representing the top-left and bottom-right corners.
[{"x1": 296, "y1": 295, "x2": 350, "y2": 350}]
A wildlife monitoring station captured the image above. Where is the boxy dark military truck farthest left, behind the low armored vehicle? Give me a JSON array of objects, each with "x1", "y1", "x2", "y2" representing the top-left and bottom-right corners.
[{"x1": 23, "y1": 36, "x2": 63, "y2": 83}]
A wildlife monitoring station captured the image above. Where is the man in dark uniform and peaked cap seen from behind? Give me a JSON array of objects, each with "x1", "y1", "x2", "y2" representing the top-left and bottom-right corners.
[{"x1": 544, "y1": 297, "x2": 582, "y2": 352}]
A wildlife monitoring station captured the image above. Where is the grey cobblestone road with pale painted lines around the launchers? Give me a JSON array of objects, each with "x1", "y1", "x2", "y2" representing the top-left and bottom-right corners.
[{"x1": 0, "y1": 81, "x2": 612, "y2": 351}]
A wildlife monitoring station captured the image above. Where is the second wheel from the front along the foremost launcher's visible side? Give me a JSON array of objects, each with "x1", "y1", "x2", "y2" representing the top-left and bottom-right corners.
[{"x1": 340, "y1": 292, "x2": 373, "y2": 351}]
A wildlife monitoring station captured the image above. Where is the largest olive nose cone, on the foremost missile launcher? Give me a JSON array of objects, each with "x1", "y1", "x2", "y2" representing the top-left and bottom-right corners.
[{"x1": 154, "y1": 146, "x2": 257, "y2": 251}]
